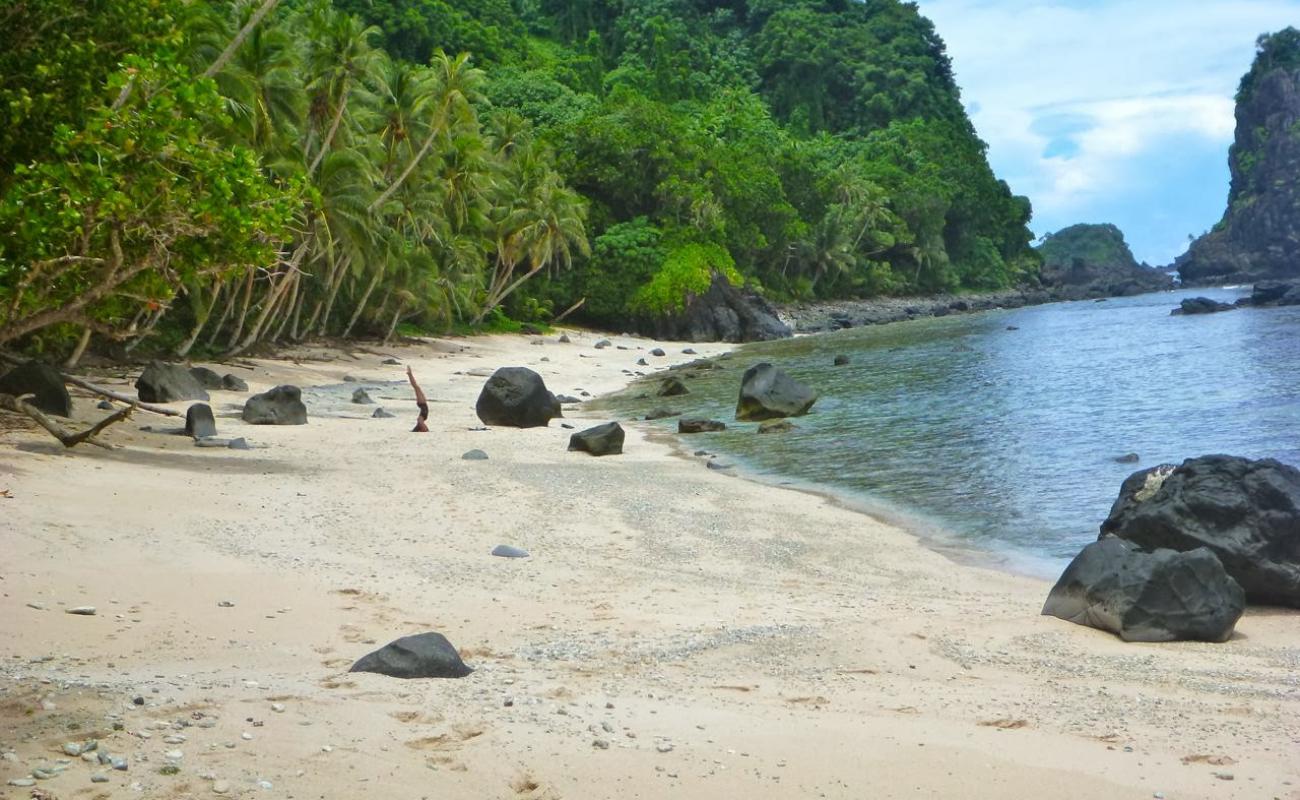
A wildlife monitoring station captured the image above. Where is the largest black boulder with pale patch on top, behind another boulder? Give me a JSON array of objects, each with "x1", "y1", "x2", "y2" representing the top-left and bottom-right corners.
[{"x1": 1101, "y1": 455, "x2": 1300, "y2": 607}]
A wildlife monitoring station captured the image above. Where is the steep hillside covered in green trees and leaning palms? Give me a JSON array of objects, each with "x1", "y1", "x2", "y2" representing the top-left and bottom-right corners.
[{"x1": 0, "y1": 0, "x2": 1037, "y2": 355}]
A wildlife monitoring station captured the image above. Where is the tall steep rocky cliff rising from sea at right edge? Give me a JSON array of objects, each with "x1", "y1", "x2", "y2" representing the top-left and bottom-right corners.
[{"x1": 1174, "y1": 27, "x2": 1300, "y2": 284}]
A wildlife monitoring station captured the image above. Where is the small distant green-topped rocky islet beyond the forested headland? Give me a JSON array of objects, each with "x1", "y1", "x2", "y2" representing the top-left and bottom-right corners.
[{"x1": 1039, "y1": 225, "x2": 1174, "y2": 298}]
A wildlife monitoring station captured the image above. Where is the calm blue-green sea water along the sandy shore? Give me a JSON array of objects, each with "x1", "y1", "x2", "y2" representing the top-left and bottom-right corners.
[{"x1": 602, "y1": 289, "x2": 1300, "y2": 575}]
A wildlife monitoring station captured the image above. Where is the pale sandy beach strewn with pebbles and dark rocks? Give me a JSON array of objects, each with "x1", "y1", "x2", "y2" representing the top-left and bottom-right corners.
[{"x1": 0, "y1": 330, "x2": 1300, "y2": 800}]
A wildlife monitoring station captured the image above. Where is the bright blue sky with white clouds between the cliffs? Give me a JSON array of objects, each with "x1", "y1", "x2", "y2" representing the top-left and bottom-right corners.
[{"x1": 918, "y1": 0, "x2": 1300, "y2": 265}]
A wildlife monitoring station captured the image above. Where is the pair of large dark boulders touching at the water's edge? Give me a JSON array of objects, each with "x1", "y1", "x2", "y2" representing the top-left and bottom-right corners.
[{"x1": 1043, "y1": 455, "x2": 1300, "y2": 641}]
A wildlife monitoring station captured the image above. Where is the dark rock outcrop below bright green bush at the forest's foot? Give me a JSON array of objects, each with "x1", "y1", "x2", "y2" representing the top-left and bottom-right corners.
[{"x1": 637, "y1": 273, "x2": 792, "y2": 342}]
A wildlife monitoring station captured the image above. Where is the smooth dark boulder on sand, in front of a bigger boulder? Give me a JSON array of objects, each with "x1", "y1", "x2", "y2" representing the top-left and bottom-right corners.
[{"x1": 1043, "y1": 539, "x2": 1245, "y2": 641}]
